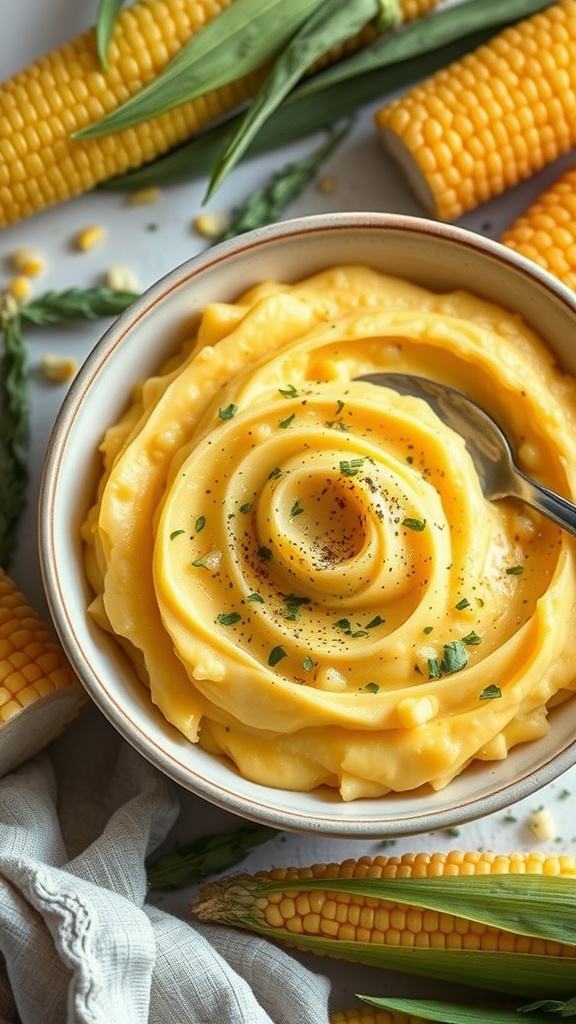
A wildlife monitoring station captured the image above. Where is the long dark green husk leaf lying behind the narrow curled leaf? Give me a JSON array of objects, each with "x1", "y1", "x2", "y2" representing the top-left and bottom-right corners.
[{"x1": 98, "y1": 0, "x2": 550, "y2": 190}]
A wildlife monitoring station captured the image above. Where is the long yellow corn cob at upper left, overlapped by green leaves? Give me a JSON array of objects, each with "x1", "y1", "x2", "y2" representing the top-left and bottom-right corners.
[{"x1": 0, "y1": 0, "x2": 440, "y2": 227}]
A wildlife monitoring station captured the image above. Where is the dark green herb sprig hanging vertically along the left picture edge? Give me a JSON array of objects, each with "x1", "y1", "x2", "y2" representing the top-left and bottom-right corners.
[{"x1": 0, "y1": 313, "x2": 30, "y2": 569}]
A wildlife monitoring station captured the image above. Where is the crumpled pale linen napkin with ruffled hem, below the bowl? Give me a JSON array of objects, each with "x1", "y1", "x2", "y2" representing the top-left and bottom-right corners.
[{"x1": 0, "y1": 708, "x2": 329, "y2": 1024}]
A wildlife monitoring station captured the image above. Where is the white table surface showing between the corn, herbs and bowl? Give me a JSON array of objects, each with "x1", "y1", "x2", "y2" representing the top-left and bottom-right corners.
[{"x1": 0, "y1": 0, "x2": 576, "y2": 1008}]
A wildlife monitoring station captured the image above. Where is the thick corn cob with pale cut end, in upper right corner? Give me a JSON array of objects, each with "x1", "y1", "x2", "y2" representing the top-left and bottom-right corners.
[{"x1": 376, "y1": 0, "x2": 576, "y2": 220}]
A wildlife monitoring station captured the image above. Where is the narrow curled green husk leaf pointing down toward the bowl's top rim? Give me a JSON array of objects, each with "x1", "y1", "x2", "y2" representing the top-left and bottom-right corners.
[{"x1": 206, "y1": 0, "x2": 391, "y2": 199}]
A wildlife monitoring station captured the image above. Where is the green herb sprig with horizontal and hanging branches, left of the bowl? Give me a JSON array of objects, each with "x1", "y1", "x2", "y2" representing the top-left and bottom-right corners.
[{"x1": 0, "y1": 288, "x2": 136, "y2": 568}]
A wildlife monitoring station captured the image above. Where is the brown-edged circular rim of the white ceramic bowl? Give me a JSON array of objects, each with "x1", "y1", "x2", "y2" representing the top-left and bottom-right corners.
[{"x1": 38, "y1": 212, "x2": 576, "y2": 839}]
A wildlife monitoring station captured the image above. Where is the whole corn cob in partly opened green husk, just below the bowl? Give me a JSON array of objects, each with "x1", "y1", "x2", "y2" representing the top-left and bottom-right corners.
[{"x1": 192, "y1": 851, "x2": 576, "y2": 998}]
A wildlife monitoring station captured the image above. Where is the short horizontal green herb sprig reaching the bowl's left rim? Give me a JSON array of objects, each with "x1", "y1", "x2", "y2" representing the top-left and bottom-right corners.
[{"x1": 19, "y1": 288, "x2": 137, "y2": 327}]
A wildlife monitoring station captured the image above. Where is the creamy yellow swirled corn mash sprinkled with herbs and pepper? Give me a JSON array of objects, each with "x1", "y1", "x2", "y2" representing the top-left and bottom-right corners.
[{"x1": 83, "y1": 266, "x2": 576, "y2": 800}]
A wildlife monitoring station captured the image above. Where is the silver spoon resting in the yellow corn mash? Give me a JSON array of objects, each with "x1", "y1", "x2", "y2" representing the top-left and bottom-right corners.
[{"x1": 356, "y1": 373, "x2": 576, "y2": 537}]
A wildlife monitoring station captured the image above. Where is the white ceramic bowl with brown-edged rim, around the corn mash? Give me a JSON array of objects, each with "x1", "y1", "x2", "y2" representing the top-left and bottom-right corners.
[{"x1": 40, "y1": 213, "x2": 576, "y2": 838}]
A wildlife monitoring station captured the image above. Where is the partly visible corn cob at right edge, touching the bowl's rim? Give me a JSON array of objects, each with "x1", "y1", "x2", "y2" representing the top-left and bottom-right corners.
[{"x1": 500, "y1": 167, "x2": 576, "y2": 289}]
